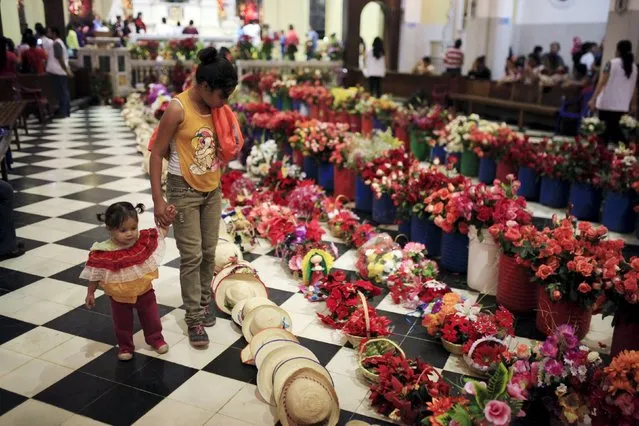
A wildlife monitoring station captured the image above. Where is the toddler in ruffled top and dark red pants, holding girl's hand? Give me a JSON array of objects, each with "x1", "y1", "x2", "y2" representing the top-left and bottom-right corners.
[{"x1": 80, "y1": 202, "x2": 175, "y2": 361}]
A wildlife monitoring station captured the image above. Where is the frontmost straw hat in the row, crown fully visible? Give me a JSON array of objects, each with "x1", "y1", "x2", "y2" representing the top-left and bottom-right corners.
[{"x1": 277, "y1": 368, "x2": 339, "y2": 426}]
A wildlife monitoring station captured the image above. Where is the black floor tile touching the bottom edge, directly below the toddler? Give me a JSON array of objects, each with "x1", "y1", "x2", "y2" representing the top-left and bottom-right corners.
[{"x1": 82, "y1": 385, "x2": 162, "y2": 426}]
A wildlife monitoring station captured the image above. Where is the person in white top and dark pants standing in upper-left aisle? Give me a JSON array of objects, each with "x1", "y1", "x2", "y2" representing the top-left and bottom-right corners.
[{"x1": 45, "y1": 28, "x2": 73, "y2": 118}]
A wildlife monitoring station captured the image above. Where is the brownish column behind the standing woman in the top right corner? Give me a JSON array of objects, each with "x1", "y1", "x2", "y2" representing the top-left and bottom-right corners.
[{"x1": 602, "y1": 0, "x2": 639, "y2": 64}]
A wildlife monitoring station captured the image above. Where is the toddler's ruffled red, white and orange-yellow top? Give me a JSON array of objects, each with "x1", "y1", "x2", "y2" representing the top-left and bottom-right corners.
[{"x1": 80, "y1": 229, "x2": 165, "y2": 303}]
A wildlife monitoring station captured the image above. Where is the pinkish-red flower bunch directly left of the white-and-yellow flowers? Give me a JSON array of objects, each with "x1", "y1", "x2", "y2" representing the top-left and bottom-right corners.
[{"x1": 289, "y1": 120, "x2": 348, "y2": 162}]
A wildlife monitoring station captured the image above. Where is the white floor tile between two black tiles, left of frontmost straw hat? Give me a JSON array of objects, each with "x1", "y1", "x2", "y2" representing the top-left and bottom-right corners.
[{"x1": 169, "y1": 372, "x2": 246, "y2": 412}]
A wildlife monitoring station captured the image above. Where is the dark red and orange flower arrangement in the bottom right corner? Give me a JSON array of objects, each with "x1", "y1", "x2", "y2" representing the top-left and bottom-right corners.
[{"x1": 590, "y1": 351, "x2": 639, "y2": 426}]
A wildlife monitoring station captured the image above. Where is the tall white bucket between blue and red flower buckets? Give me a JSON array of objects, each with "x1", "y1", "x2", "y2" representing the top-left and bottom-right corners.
[{"x1": 467, "y1": 226, "x2": 500, "y2": 296}]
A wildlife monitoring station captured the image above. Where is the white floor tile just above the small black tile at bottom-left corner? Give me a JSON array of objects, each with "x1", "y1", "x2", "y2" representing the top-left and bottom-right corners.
[{"x1": 0, "y1": 359, "x2": 73, "y2": 398}]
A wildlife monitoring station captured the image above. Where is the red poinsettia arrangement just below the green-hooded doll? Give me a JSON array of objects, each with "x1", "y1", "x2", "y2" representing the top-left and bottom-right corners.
[{"x1": 317, "y1": 270, "x2": 381, "y2": 329}]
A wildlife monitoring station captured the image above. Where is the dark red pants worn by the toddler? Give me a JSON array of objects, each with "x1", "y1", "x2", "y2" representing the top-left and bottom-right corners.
[{"x1": 111, "y1": 289, "x2": 165, "y2": 353}]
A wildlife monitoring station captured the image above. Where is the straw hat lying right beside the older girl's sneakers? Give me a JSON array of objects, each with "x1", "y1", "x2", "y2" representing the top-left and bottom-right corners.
[{"x1": 211, "y1": 262, "x2": 267, "y2": 314}]
